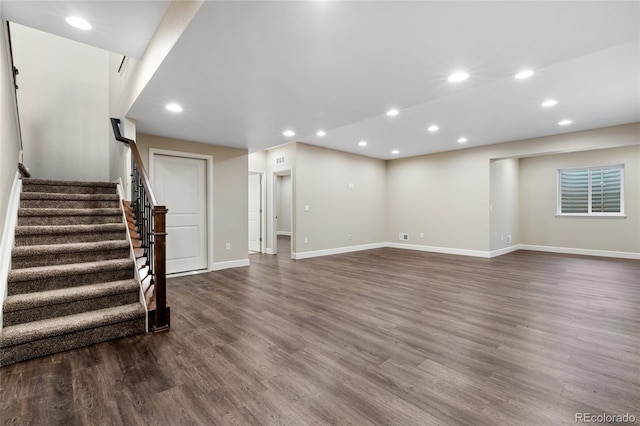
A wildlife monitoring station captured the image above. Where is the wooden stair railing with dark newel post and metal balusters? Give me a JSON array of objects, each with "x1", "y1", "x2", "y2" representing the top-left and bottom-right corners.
[{"x1": 111, "y1": 118, "x2": 169, "y2": 333}]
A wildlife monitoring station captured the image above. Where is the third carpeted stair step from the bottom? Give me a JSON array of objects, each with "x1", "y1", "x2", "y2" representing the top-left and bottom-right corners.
[{"x1": 7, "y1": 259, "x2": 135, "y2": 296}]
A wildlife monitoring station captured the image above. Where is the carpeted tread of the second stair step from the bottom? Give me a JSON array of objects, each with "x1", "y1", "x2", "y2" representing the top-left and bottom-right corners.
[{"x1": 4, "y1": 279, "x2": 140, "y2": 314}]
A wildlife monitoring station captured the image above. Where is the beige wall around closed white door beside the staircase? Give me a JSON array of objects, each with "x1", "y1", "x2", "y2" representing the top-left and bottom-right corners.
[{"x1": 136, "y1": 133, "x2": 249, "y2": 262}]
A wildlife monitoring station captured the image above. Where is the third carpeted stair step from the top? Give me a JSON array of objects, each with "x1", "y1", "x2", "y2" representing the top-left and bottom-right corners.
[{"x1": 18, "y1": 208, "x2": 122, "y2": 226}]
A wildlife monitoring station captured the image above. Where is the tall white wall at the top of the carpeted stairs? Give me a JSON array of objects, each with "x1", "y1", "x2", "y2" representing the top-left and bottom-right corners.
[{"x1": 11, "y1": 24, "x2": 109, "y2": 181}]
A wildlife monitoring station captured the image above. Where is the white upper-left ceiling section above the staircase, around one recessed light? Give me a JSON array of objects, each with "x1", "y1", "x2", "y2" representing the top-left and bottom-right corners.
[{"x1": 0, "y1": 0, "x2": 170, "y2": 58}]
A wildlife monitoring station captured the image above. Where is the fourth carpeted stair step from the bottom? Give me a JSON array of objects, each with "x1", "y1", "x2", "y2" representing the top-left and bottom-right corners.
[{"x1": 11, "y1": 240, "x2": 131, "y2": 269}]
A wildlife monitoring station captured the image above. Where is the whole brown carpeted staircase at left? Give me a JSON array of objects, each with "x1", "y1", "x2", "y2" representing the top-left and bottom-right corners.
[{"x1": 0, "y1": 179, "x2": 146, "y2": 366}]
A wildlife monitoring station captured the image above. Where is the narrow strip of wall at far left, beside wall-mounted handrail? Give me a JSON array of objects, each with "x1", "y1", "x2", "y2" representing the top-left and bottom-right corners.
[{"x1": 0, "y1": 21, "x2": 20, "y2": 236}]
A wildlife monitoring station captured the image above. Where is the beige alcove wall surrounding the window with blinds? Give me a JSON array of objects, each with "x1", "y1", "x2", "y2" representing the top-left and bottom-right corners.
[{"x1": 520, "y1": 145, "x2": 640, "y2": 253}]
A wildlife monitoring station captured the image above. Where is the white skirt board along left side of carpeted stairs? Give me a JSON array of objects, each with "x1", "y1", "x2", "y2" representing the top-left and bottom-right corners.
[{"x1": 0, "y1": 172, "x2": 22, "y2": 330}]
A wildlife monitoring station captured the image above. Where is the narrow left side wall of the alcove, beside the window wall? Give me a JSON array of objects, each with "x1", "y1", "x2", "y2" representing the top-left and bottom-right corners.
[{"x1": 489, "y1": 158, "x2": 520, "y2": 251}]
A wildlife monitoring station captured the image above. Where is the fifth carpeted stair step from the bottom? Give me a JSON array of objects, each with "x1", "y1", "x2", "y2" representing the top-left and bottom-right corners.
[{"x1": 15, "y1": 223, "x2": 127, "y2": 246}]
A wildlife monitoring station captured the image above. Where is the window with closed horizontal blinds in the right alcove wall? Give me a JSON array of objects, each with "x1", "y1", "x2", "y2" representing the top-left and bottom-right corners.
[{"x1": 558, "y1": 164, "x2": 624, "y2": 216}]
